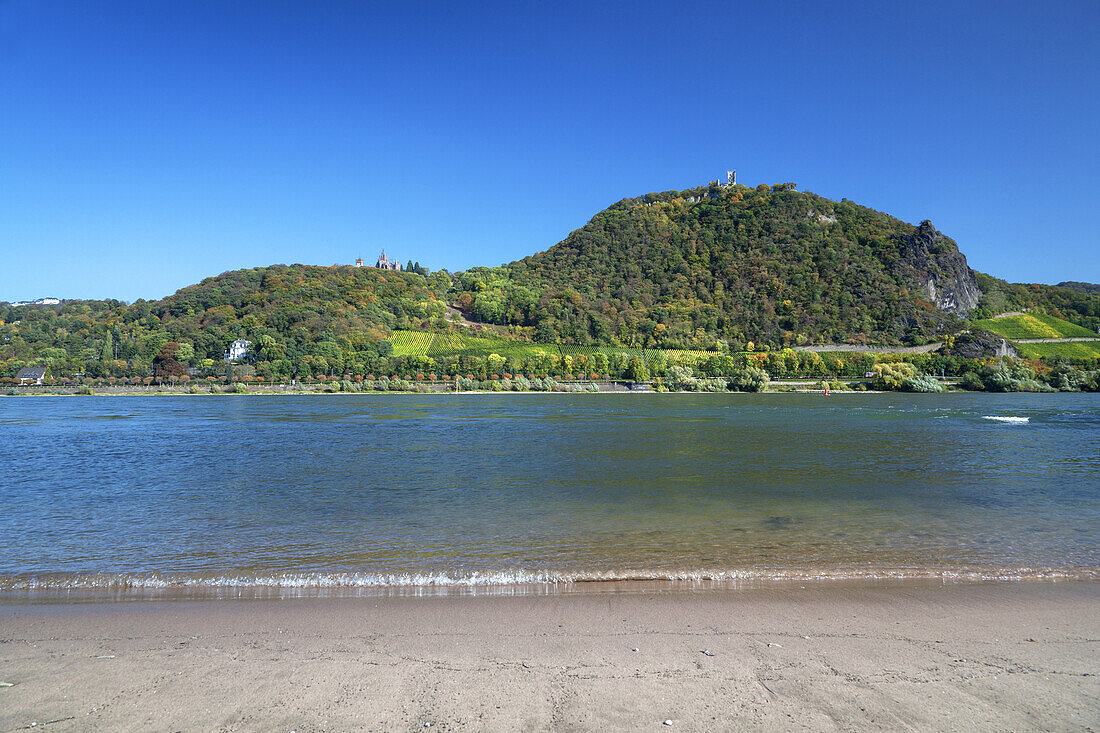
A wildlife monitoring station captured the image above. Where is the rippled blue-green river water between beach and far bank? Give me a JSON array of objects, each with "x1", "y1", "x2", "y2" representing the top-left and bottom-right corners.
[{"x1": 0, "y1": 394, "x2": 1100, "y2": 590}]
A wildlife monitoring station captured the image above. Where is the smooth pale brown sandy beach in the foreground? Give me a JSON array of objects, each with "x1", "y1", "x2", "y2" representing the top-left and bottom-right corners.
[{"x1": 0, "y1": 582, "x2": 1100, "y2": 732}]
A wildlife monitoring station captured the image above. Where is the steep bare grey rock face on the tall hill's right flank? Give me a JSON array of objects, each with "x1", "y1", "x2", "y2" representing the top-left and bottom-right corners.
[{"x1": 894, "y1": 221, "x2": 981, "y2": 318}]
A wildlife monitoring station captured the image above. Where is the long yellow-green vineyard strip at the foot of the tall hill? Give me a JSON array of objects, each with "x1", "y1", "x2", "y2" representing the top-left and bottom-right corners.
[{"x1": 391, "y1": 331, "x2": 714, "y2": 364}]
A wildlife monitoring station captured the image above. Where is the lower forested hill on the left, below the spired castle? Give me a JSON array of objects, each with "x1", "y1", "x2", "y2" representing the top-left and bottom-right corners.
[{"x1": 0, "y1": 265, "x2": 451, "y2": 379}]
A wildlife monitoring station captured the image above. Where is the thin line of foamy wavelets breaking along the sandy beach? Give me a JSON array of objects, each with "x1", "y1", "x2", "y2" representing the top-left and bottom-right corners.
[{"x1": 0, "y1": 567, "x2": 1100, "y2": 609}]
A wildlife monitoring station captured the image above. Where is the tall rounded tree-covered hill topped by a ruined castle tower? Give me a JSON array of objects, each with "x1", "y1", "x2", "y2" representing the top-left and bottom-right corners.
[{"x1": 457, "y1": 179, "x2": 981, "y2": 348}]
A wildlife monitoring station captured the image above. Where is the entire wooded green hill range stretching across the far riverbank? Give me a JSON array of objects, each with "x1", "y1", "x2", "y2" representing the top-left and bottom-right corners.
[{"x1": 0, "y1": 184, "x2": 1100, "y2": 382}]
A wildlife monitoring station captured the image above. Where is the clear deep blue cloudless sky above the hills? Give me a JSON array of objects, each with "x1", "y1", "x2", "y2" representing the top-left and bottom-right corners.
[{"x1": 0, "y1": 0, "x2": 1100, "y2": 300}]
